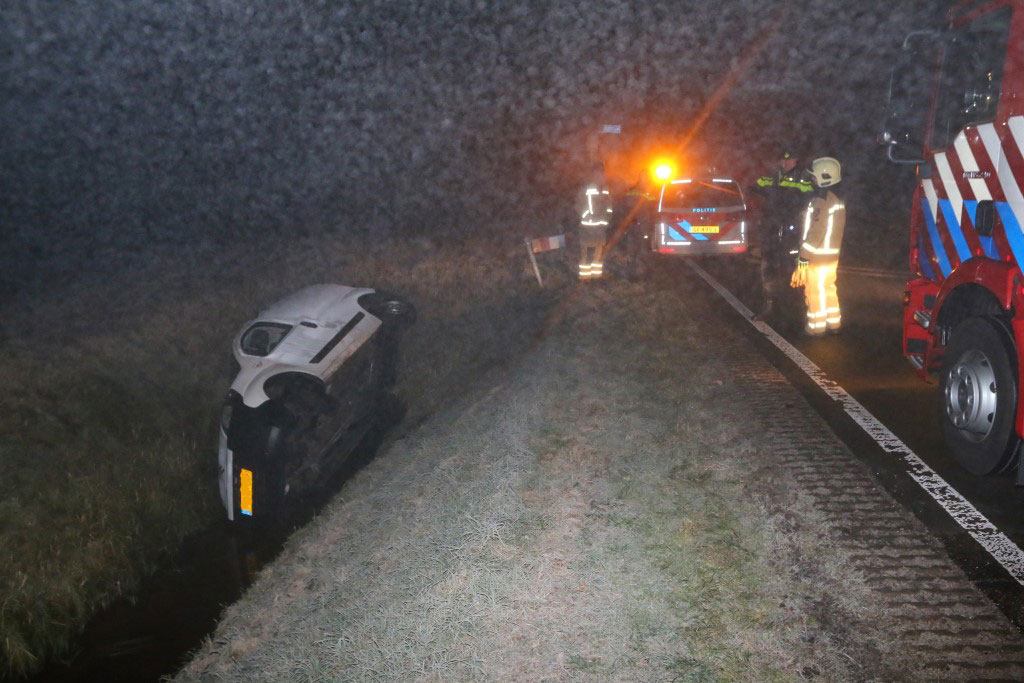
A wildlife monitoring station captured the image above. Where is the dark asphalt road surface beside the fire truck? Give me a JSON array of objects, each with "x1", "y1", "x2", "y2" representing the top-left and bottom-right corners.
[{"x1": 675, "y1": 254, "x2": 1024, "y2": 629}]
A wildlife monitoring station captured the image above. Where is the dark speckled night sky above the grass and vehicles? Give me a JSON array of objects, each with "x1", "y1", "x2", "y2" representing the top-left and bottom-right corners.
[{"x1": 0, "y1": 0, "x2": 945, "y2": 298}]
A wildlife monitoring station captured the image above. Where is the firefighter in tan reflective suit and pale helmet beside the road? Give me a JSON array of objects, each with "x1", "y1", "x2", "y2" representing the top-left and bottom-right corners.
[{"x1": 790, "y1": 157, "x2": 846, "y2": 335}]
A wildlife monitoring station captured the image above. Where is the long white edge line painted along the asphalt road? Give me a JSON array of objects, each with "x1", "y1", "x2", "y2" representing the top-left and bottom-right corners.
[{"x1": 688, "y1": 261, "x2": 1024, "y2": 585}]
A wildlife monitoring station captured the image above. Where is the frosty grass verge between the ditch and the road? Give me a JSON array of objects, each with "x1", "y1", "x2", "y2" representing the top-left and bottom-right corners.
[{"x1": 179, "y1": 276, "x2": 888, "y2": 681}]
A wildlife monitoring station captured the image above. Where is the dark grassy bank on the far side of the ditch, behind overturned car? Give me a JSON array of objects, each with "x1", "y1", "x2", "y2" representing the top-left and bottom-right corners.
[{"x1": 0, "y1": 225, "x2": 570, "y2": 674}]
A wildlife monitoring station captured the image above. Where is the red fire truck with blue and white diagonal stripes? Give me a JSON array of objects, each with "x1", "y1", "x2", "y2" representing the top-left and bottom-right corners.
[{"x1": 882, "y1": 0, "x2": 1024, "y2": 483}]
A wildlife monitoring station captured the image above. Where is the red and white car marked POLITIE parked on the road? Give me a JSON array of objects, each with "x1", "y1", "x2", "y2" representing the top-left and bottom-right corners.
[{"x1": 646, "y1": 175, "x2": 748, "y2": 256}]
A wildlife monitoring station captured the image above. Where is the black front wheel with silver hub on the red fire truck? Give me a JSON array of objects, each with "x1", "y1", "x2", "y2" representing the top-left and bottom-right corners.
[{"x1": 939, "y1": 317, "x2": 1018, "y2": 474}]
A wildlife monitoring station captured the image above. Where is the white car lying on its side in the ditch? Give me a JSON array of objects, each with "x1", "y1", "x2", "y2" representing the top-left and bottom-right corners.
[{"x1": 218, "y1": 285, "x2": 415, "y2": 521}]
